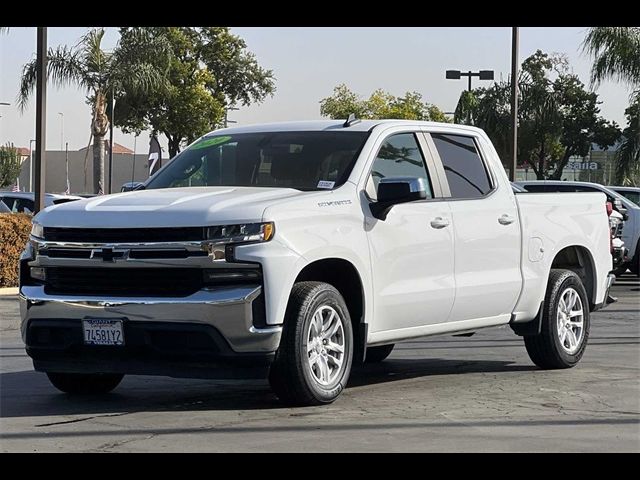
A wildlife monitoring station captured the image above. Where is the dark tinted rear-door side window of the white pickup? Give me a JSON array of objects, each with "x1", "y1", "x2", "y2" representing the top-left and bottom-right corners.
[{"x1": 431, "y1": 133, "x2": 491, "y2": 198}]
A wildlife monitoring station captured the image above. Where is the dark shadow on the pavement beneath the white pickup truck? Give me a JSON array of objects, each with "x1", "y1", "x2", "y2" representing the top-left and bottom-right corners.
[{"x1": 0, "y1": 358, "x2": 536, "y2": 418}]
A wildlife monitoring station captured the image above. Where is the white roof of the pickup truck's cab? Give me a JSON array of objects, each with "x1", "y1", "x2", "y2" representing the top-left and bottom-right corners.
[{"x1": 207, "y1": 120, "x2": 479, "y2": 135}]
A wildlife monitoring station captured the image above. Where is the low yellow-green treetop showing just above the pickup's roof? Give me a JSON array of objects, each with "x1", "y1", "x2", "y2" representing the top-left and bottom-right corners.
[{"x1": 320, "y1": 84, "x2": 448, "y2": 122}]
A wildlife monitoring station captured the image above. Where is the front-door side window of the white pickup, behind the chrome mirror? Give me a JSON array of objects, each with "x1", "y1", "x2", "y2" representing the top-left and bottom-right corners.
[{"x1": 366, "y1": 133, "x2": 433, "y2": 199}]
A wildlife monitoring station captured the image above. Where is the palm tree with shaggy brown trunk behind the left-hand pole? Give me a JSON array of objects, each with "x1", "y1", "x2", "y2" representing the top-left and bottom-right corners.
[{"x1": 18, "y1": 28, "x2": 165, "y2": 194}]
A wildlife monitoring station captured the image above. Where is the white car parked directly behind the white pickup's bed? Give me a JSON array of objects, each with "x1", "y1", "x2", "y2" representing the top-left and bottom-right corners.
[{"x1": 516, "y1": 180, "x2": 640, "y2": 275}]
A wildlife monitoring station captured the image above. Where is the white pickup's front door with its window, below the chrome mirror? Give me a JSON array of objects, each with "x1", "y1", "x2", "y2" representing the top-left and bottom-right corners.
[{"x1": 365, "y1": 133, "x2": 455, "y2": 338}]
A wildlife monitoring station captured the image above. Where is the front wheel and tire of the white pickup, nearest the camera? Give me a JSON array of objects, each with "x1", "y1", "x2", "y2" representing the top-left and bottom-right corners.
[{"x1": 269, "y1": 282, "x2": 353, "y2": 406}]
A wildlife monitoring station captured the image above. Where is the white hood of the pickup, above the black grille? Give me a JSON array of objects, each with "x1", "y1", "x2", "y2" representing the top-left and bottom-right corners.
[{"x1": 35, "y1": 187, "x2": 309, "y2": 228}]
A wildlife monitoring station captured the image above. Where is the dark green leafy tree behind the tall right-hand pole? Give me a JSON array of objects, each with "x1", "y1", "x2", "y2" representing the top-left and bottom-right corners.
[{"x1": 454, "y1": 50, "x2": 620, "y2": 179}]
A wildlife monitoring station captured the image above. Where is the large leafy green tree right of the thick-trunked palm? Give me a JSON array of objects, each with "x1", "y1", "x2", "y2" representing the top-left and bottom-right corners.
[{"x1": 115, "y1": 27, "x2": 275, "y2": 157}]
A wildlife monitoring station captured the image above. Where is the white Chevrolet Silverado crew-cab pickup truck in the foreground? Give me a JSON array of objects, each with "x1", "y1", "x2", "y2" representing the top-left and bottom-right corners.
[{"x1": 20, "y1": 119, "x2": 613, "y2": 405}]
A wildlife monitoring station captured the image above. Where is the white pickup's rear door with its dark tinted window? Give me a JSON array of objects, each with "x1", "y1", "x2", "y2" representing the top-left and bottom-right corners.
[{"x1": 426, "y1": 133, "x2": 522, "y2": 322}]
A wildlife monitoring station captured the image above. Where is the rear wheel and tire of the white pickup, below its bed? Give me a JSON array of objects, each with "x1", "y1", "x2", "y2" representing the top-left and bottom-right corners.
[{"x1": 524, "y1": 269, "x2": 590, "y2": 369}]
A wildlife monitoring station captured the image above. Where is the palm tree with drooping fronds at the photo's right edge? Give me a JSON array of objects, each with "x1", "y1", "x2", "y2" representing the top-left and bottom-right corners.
[{"x1": 583, "y1": 27, "x2": 640, "y2": 184}]
